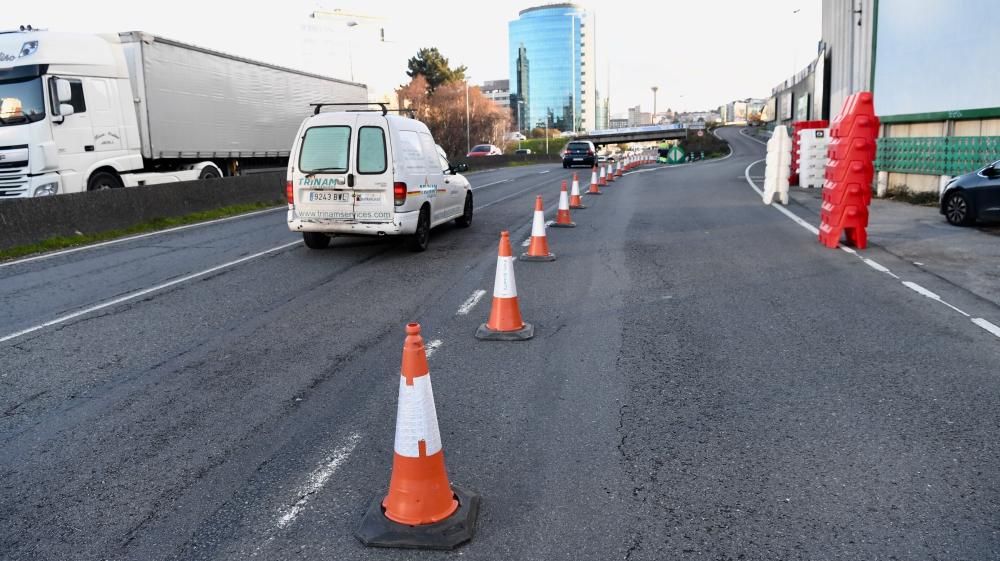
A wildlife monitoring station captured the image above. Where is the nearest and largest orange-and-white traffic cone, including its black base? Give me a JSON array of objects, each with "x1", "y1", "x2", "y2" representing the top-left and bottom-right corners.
[{"x1": 355, "y1": 323, "x2": 479, "y2": 549}]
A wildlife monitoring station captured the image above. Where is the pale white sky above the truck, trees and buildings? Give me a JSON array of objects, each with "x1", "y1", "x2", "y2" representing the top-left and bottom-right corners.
[{"x1": 3, "y1": 0, "x2": 821, "y2": 115}]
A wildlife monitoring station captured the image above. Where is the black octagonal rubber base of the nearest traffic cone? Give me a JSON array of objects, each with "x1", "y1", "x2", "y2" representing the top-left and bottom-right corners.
[{"x1": 354, "y1": 484, "x2": 479, "y2": 550}]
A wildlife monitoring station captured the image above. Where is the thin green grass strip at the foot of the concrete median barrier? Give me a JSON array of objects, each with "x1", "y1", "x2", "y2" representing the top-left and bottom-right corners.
[{"x1": 0, "y1": 200, "x2": 285, "y2": 261}]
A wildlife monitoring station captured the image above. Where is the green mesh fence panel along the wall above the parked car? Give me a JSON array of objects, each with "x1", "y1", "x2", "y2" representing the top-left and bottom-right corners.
[{"x1": 875, "y1": 136, "x2": 1000, "y2": 176}]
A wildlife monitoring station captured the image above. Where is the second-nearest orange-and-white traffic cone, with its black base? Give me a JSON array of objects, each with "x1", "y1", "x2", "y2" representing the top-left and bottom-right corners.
[{"x1": 476, "y1": 231, "x2": 535, "y2": 341}]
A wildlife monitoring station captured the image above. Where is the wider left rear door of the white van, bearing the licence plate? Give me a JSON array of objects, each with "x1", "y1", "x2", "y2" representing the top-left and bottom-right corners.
[{"x1": 295, "y1": 114, "x2": 357, "y2": 222}]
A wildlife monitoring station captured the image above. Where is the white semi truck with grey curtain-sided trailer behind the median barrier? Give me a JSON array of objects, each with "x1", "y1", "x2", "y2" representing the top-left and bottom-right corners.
[{"x1": 0, "y1": 28, "x2": 368, "y2": 199}]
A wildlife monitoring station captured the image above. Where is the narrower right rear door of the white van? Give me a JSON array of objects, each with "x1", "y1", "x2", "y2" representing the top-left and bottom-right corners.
[{"x1": 353, "y1": 113, "x2": 395, "y2": 222}]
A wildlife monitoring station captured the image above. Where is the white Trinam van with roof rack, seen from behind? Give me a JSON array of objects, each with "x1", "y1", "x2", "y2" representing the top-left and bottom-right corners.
[{"x1": 285, "y1": 104, "x2": 473, "y2": 251}]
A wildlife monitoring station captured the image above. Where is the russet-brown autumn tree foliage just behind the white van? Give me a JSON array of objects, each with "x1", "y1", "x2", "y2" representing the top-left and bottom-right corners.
[{"x1": 396, "y1": 74, "x2": 510, "y2": 156}]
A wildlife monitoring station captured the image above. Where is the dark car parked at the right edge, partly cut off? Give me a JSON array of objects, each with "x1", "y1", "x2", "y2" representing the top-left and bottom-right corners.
[{"x1": 941, "y1": 161, "x2": 1000, "y2": 226}]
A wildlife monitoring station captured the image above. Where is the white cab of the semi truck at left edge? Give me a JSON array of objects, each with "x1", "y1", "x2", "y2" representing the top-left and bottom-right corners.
[{"x1": 0, "y1": 30, "x2": 143, "y2": 198}]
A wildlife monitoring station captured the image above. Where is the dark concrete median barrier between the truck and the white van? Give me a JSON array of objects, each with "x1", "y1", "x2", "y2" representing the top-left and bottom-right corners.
[{"x1": 0, "y1": 172, "x2": 285, "y2": 249}]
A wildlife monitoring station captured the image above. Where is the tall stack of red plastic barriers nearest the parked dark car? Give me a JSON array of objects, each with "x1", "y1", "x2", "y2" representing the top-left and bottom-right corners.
[{"x1": 819, "y1": 92, "x2": 879, "y2": 249}]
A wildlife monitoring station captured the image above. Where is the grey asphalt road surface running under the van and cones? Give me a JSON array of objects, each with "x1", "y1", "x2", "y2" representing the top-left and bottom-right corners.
[{"x1": 0, "y1": 130, "x2": 1000, "y2": 560}]
